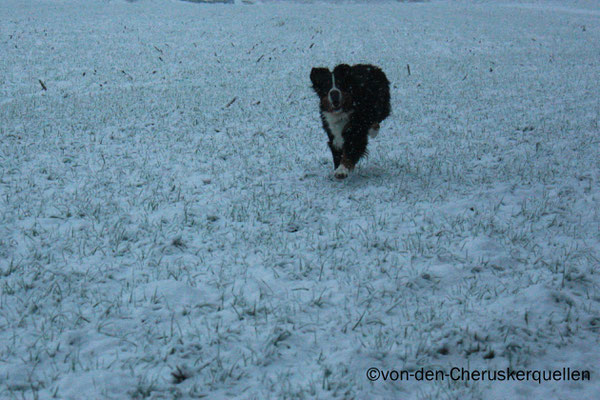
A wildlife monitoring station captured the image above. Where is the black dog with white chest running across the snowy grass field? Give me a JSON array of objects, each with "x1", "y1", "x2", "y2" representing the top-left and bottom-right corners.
[{"x1": 310, "y1": 64, "x2": 390, "y2": 179}]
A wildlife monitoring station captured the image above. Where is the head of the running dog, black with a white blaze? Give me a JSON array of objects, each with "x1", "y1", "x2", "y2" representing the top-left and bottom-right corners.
[{"x1": 310, "y1": 64, "x2": 352, "y2": 113}]
